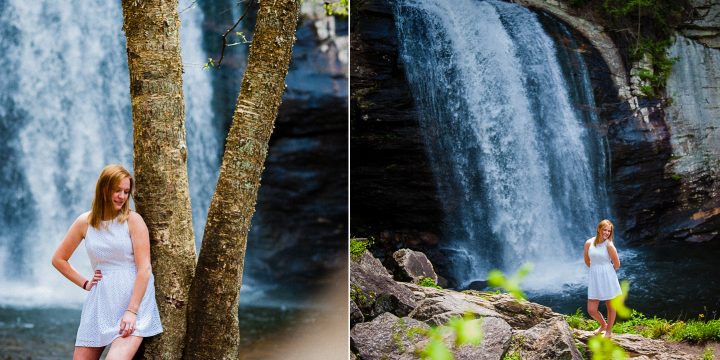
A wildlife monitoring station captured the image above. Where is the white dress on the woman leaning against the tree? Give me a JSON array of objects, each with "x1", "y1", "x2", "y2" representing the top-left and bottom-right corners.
[{"x1": 75, "y1": 220, "x2": 163, "y2": 347}]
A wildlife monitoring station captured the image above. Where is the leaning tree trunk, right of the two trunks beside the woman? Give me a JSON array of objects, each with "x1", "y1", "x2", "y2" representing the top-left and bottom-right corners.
[{"x1": 185, "y1": 0, "x2": 299, "y2": 359}]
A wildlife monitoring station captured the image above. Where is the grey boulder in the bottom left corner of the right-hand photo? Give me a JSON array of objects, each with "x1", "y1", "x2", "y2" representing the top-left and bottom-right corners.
[{"x1": 350, "y1": 312, "x2": 430, "y2": 360}]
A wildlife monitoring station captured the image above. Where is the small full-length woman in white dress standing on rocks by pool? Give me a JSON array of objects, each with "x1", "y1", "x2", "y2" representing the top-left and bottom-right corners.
[{"x1": 585, "y1": 220, "x2": 622, "y2": 337}]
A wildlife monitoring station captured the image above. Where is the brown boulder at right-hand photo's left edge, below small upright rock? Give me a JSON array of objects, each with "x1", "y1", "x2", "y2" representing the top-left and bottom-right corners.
[{"x1": 350, "y1": 251, "x2": 417, "y2": 319}]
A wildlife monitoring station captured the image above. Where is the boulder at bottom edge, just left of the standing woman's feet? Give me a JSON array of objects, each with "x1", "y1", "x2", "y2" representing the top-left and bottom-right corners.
[{"x1": 513, "y1": 316, "x2": 582, "y2": 360}]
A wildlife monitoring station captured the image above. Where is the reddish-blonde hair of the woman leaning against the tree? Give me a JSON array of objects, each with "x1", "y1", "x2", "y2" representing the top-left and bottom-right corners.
[{"x1": 88, "y1": 164, "x2": 135, "y2": 229}]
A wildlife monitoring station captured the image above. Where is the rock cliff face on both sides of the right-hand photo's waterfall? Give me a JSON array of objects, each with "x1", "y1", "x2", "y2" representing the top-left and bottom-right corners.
[{"x1": 351, "y1": 0, "x2": 720, "y2": 246}]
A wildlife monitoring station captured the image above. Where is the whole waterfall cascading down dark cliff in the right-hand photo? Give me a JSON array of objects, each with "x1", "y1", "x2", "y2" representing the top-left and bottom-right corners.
[{"x1": 395, "y1": 0, "x2": 608, "y2": 289}]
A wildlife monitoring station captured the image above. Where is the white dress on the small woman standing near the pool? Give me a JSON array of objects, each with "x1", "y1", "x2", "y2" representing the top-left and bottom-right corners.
[{"x1": 588, "y1": 238, "x2": 622, "y2": 300}]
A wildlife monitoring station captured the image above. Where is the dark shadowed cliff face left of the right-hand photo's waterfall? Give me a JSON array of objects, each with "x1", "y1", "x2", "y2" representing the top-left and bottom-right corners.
[{"x1": 350, "y1": 0, "x2": 442, "y2": 237}]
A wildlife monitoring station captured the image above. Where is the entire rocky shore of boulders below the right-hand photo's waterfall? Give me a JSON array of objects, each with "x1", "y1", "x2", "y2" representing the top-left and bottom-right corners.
[{"x1": 350, "y1": 249, "x2": 699, "y2": 360}]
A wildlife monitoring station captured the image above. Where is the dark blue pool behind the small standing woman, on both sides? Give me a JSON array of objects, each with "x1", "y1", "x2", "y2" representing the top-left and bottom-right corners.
[{"x1": 526, "y1": 244, "x2": 720, "y2": 320}]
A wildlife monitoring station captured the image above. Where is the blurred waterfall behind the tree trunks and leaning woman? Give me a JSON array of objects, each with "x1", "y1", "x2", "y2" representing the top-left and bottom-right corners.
[{"x1": 0, "y1": 0, "x2": 222, "y2": 306}]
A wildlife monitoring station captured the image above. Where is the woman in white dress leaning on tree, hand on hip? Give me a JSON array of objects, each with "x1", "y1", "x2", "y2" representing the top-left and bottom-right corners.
[{"x1": 52, "y1": 165, "x2": 162, "y2": 360}]
